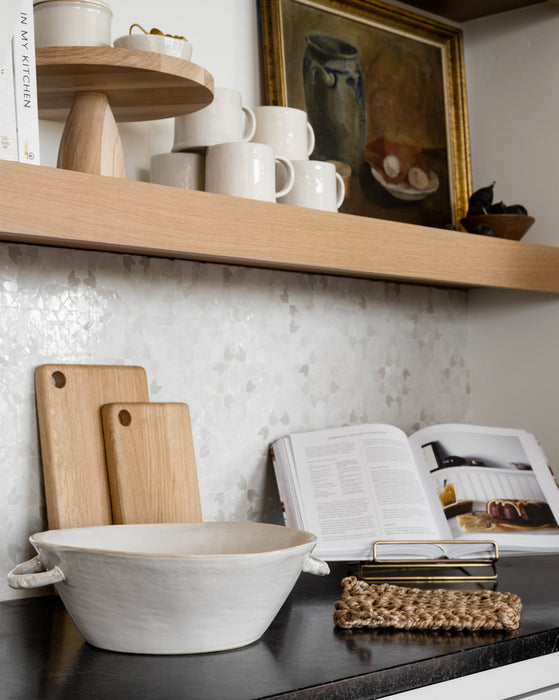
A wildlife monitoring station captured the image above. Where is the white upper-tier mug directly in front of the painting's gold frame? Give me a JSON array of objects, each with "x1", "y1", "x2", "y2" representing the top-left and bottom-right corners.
[{"x1": 252, "y1": 105, "x2": 314, "y2": 160}]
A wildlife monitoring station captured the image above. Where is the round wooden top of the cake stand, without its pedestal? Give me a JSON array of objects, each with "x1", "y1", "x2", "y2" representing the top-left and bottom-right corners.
[{"x1": 36, "y1": 46, "x2": 214, "y2": 122}]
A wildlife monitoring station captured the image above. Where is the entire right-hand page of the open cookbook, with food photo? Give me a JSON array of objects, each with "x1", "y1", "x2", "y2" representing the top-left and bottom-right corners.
[{"x1": 410, "y1": 424, "x2": 559, "y2": 551}]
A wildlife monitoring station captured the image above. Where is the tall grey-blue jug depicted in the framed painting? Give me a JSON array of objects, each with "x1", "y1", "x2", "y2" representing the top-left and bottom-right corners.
[{"x1": 303, "y1": 32, "x2": 366, "y2": 172}]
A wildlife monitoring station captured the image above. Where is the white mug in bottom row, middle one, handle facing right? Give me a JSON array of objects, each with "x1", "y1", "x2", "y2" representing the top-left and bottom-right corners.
[{"x1": 206, "y1": 141, "x2": 295, "y2": 202}]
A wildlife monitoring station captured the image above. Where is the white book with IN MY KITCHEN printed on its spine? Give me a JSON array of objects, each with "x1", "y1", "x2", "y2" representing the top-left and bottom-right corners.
[{"x1": 12, "y1": 0, "x2": 40, "y2": 165}]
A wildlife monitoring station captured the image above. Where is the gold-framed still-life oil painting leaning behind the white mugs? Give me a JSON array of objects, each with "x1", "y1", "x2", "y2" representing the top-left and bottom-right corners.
[{"x1": 258, "y1": 0, "x2": 471, "y2": 228}]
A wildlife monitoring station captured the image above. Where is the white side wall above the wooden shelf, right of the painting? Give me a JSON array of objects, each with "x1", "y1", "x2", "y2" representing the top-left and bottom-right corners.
[{"x1": 463, "y1": 4, "x2": 559, "y2": 250}]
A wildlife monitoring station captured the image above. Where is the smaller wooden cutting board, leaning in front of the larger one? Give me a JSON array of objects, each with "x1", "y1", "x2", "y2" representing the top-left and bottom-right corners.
[{"x1": 102, "y1": 402, "x2": 202, "y2": 524}]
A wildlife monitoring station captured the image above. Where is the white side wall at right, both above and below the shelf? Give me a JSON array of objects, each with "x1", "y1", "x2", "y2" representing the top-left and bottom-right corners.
[{"x1": 464, "y1": 4, "x2": 559, "y2": 467}]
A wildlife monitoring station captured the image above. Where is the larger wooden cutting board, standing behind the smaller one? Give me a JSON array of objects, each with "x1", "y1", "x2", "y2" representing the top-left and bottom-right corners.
[{"x1": 35, "y1": 365, "x2": 149, "y2": 529}]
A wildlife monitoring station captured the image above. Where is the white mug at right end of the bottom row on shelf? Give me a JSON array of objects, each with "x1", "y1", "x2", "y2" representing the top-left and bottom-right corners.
[{"x1": 278, "y1": 160, "x2": 345, "y2": 211}]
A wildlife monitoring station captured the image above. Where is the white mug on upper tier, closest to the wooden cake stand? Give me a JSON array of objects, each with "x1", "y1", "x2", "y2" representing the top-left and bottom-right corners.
[{"x1": 172, "y1": 88, "x2": 256, "y2": 151}]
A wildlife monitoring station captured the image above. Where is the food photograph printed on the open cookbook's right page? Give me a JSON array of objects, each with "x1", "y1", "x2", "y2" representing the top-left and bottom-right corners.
[{"x1": 422, "y1": 432, "x2": 559, "y2": 537}]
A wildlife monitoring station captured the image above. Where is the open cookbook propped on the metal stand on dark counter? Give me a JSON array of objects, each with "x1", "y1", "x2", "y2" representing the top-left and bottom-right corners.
[{"x1": 271, "y1": 424, "x2": 559, "y2": 561}]
